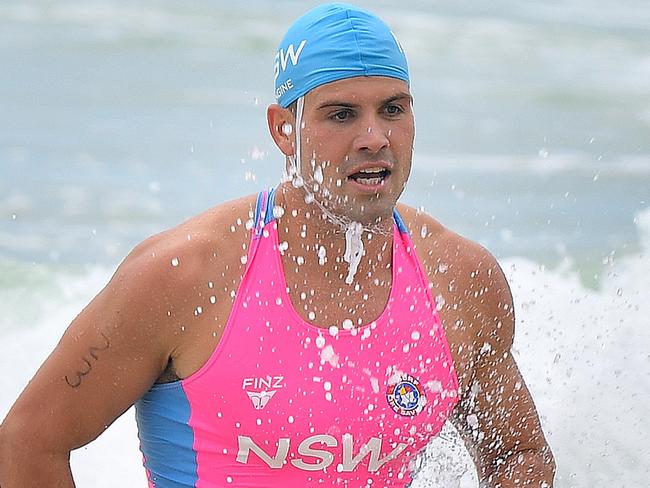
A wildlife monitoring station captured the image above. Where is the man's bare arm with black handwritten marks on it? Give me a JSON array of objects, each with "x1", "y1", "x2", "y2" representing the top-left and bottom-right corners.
[{"x1": 0, "y1": 238, "x2": 185, "y2": 488}]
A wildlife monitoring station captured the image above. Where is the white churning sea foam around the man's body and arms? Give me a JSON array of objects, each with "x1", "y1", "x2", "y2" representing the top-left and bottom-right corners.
[{"x1": 0, "y1": 211, "x2": 650, "y2": 488}]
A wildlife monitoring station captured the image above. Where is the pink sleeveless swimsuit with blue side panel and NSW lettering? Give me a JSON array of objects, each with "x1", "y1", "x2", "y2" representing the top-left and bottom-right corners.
[{"x1": 136, "y1": 191, "x2": 458, "y2": 488}]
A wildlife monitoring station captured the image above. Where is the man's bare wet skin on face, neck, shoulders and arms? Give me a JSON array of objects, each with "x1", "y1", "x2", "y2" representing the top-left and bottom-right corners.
[{"x1": 0, "y1": 78, "x2": 554, "y2": 488}]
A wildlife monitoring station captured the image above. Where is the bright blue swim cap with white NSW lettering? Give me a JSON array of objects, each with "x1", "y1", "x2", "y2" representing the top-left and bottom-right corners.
[{"x1": 274, "y1": 3, "x2": 409, "y2": 108}]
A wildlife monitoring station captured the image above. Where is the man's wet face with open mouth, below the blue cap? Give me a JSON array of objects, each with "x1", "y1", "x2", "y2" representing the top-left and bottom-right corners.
[{"x1": 301, "y1": 76, "x2": 415, "y2": 223}]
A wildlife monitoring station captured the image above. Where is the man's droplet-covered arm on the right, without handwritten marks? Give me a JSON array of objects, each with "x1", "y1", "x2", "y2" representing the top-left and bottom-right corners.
[{"x1": 454, "y1": 252, "x2": 555, "y2": 488}]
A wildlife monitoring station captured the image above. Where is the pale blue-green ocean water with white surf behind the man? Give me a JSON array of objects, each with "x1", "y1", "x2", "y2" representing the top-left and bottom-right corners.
[{"x1": 0, "y1": 0, "x2": 650, "y2": 488}]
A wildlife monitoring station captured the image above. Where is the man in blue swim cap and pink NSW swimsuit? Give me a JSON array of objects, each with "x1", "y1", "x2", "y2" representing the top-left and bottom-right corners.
[{"x1": 0, "y1": 4, "x2": 554, "y2": 488}]
